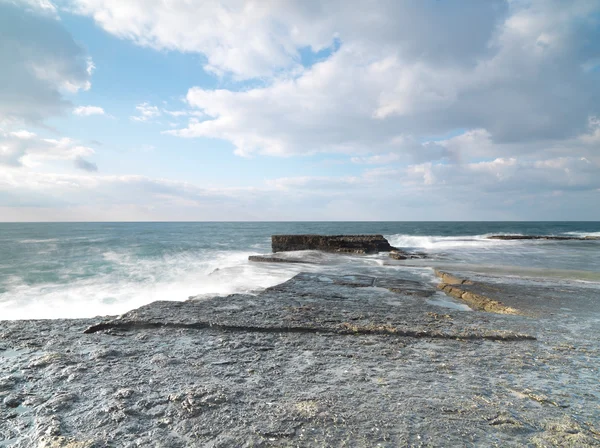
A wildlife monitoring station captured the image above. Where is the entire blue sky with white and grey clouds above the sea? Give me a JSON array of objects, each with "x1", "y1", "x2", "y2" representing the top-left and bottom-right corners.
[{"x1": 0, "y1": 0, "x2": 600, "y2": 221}]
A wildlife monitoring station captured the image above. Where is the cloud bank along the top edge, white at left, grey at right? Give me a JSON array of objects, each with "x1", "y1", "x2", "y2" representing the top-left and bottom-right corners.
[{"x1": 72, "y1": 0, "x2": 507, "y2": 79}]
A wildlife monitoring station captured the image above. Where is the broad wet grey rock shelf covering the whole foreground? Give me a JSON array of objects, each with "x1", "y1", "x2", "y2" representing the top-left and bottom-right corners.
[{"x1": 0, "y1": 272, "x2": 600, "y2": 447}]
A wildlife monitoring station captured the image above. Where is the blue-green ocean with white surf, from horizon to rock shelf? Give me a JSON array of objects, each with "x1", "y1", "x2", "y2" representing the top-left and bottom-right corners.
[{"x1": 0, "y1": 222, "x2": 600, "y2": 319}]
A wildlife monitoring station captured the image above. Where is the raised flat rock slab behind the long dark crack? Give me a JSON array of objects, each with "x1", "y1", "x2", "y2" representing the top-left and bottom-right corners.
[{"x1": 87, "y1": 273, "x2": 534, "y2": 340}]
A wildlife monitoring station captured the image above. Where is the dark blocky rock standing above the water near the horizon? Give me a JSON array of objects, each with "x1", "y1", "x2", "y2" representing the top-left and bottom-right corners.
[{"x1": 271, "y1": 235, "x2": 395, "y2": 254}]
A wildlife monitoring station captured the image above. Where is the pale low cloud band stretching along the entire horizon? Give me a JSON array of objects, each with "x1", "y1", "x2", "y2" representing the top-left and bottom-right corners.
[{"x1": 0, "y1": 150, "x2": 600, "y2": 220}]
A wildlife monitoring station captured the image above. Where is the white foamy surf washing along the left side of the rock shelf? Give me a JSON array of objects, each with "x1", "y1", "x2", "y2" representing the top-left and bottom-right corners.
[{"x1": 0, "y1": 251, "x2": 301, "y2": 320}]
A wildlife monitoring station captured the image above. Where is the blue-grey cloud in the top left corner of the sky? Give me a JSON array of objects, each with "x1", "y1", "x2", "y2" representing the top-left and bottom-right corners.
[{"x1": 0, "y1": 1, "x2": 90, "y2": 124}]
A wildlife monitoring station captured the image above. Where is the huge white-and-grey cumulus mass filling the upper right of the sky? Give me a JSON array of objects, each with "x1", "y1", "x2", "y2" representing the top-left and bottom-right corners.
[{"x1": 73, "y1": 0, "x2": 600, "y2": 158}]
